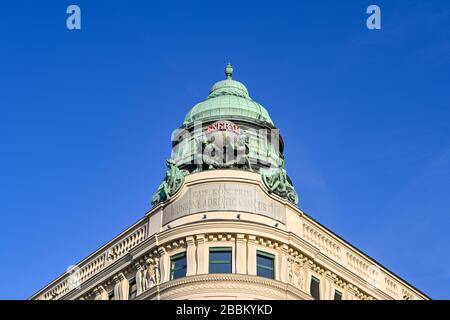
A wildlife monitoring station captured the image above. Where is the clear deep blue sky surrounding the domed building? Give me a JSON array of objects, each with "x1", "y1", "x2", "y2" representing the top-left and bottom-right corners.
[{"x1": 0, "y1": 0, "x2": 450, "y2": 299}]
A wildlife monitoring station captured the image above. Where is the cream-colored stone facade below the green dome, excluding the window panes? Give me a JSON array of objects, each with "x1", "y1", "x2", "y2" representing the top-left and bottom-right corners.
[{"x1": 31, "y1": 170, "x2": 428, "y2": 300}]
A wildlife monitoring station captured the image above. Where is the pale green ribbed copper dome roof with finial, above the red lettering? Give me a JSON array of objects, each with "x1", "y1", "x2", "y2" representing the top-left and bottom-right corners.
[{"x1": 183, "y1": 64, "x2": 274, "y2": 127}]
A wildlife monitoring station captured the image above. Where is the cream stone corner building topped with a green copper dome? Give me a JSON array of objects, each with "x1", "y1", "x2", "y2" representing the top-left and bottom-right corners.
[{"x1": 31, "y1": 65, "x2": 429, "y2": 300}]
